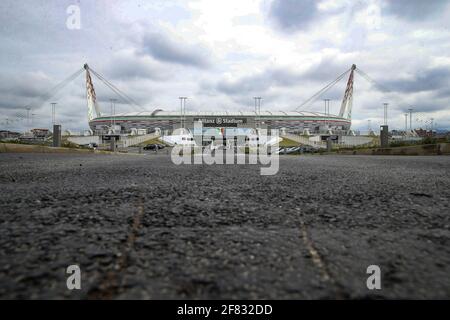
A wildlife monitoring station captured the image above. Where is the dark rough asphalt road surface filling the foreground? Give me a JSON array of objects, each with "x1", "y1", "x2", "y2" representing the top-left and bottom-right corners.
[{"x1": 0, "y1": 154, "x2": 450, "y2": 299}]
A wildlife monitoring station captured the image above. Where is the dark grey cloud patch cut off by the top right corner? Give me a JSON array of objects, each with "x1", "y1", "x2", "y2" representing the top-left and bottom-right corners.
[{"x1": 385, "y1": 0, "x2": 449, "y2": 21}]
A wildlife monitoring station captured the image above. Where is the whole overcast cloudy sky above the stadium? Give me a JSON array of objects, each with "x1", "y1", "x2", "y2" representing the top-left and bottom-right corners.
[{"x1": 0, "y1": 0, "x2": 450, "y2": 130}]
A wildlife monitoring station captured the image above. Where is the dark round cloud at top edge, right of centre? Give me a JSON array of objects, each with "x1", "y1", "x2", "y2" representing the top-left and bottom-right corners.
[{"x1": 269, "y1": 0, "x2": 318, "y2": 31}]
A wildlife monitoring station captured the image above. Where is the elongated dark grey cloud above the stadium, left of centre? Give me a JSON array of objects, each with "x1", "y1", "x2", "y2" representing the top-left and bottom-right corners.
[{"x1": 142, "y1": 33, "x2": 210, "y2": 68}]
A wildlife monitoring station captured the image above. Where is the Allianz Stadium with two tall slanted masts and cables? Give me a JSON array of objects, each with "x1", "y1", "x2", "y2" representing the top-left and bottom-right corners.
[{"x1": 84, "y1": 64, "x2": 356, "y2": 135}]
